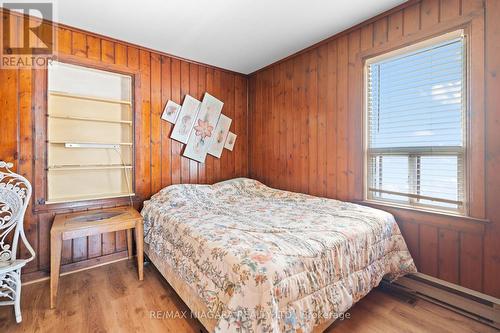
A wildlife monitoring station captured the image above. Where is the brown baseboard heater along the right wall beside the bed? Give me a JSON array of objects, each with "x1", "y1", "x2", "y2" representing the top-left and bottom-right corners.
[{"x1": 381, "y1": 273, "x2": 500, "y2": 329}]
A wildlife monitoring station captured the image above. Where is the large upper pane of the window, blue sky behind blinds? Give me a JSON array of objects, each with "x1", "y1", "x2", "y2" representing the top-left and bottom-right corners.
[{"x1": 369, "y1": 40, "x2": 463, "y2": 148}]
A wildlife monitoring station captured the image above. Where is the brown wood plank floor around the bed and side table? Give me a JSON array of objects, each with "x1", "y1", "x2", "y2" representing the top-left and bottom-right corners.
[{"x1": 0, "y1": 260, "x2": 497, "y2": 333}]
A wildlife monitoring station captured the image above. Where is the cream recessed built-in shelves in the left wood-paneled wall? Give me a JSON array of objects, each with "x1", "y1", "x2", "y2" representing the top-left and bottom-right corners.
[{"x1": 46, "y1": 61, "x2": 134, "y2": 203}]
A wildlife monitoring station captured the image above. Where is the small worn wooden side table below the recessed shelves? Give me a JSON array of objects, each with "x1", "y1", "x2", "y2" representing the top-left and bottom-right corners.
[{"x1": 50, "y1": 207, "x2": 144, "y2": 309}]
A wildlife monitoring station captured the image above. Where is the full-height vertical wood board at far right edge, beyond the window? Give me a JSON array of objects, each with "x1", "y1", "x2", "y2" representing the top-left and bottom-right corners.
[{"x1": 483, "y1": 0, "x2": 500, "y2": 297}]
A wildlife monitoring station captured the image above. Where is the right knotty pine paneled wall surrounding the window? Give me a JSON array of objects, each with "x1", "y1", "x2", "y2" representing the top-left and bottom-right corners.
[{"x1": 249, "y1": 0, "x2": 500, "y2": 297}]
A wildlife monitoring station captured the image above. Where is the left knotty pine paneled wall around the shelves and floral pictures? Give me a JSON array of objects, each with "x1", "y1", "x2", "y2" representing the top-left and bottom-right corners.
[{"x1": 0, "y1": 12, "x2": 248, "y2": 279}]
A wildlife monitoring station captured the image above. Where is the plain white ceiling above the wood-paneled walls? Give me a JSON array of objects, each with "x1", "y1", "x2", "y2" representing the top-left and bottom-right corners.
[{"x1": 48, "y1": 0, "x2": 405, "y2": 74}]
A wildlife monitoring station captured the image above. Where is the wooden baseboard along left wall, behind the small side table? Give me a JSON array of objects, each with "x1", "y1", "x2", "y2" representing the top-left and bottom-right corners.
[{"x1": 21, "y1": 250, "x2": 128, "y2": 285}]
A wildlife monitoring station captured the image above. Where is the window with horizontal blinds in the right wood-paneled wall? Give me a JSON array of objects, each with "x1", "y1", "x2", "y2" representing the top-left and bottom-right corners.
[{"x1": 366, "y1": 31, "x2": 467, "y2": 214}]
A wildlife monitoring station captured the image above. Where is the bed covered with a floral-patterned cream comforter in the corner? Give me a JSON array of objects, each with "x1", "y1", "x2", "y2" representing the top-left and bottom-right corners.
[{"x1": 142, "y1": 178, "x2": 416, "y2": 332}]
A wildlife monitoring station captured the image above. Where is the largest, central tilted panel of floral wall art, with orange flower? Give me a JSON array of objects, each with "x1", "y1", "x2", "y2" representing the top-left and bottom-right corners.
[{"x1": 183, "y1": 93, "x2": 224, "y2": 163}]
